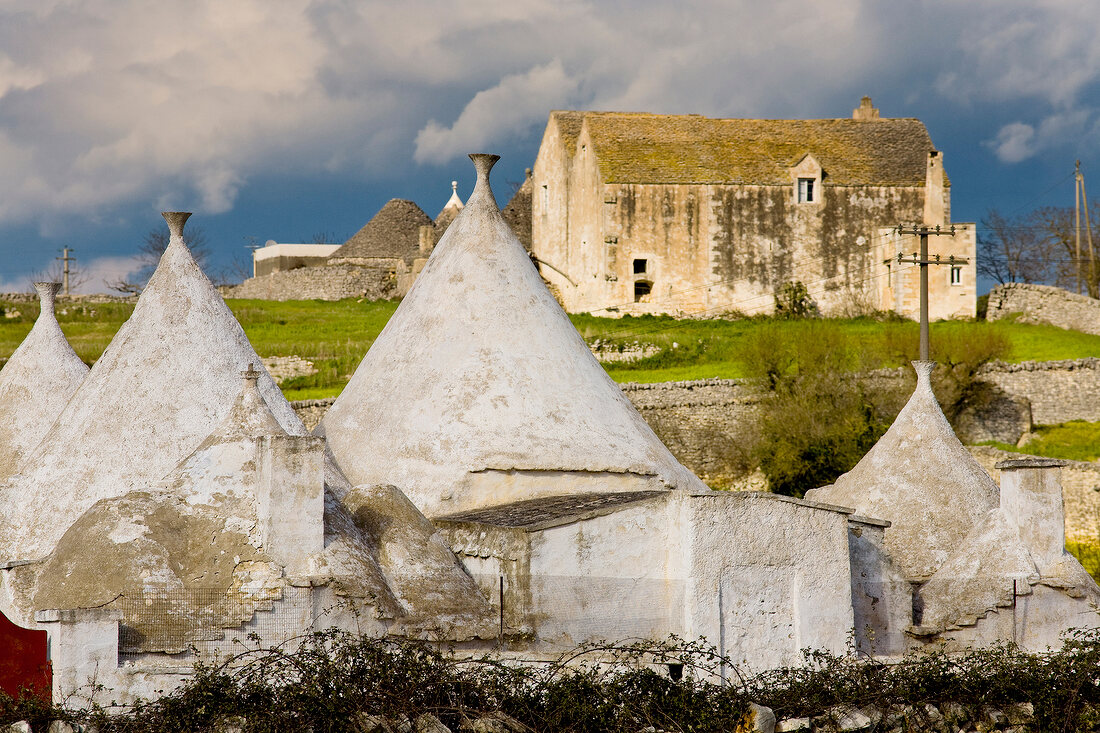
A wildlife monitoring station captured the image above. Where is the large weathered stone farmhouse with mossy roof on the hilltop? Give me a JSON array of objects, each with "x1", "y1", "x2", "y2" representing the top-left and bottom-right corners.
[{"x1": 531, "y1": 97, "x2": 977, "y2": 318}]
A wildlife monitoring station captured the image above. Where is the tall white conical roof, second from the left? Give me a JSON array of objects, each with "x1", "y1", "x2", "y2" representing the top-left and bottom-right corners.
[{"x1": 0, "y1": 214, "x2": 306, "y2": 559}]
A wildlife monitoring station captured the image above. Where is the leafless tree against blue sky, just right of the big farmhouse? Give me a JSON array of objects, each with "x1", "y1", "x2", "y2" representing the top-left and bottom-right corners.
[{"x1": 978, "y1": 209, "x2": 1058, "y2": 285}]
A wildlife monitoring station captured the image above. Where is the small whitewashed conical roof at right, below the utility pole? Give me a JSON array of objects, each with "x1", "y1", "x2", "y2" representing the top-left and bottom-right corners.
[{"x1": 806, "y1": 361, "x2": 999, "y2": 579}]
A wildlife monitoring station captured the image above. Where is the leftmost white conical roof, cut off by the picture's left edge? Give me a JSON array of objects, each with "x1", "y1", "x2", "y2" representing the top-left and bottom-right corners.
[{"x1": 0, "y1": 283, "x2": 88, "y2": 481}]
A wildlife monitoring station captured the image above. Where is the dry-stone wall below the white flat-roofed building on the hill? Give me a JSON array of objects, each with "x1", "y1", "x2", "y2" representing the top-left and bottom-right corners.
[{"x1": 221, "y1": 265, "x2": 397, "y2": 300}]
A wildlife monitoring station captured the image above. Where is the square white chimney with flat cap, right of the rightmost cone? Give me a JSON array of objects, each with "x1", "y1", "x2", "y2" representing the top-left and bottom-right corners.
[{"x1": 996, "y1": 458, "x2": 1067, "y2": 571}]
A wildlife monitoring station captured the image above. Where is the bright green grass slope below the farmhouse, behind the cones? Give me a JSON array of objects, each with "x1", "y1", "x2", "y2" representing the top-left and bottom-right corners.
[{"x1": 0, "y1": 300, "x2": 1100, "y2": 400}]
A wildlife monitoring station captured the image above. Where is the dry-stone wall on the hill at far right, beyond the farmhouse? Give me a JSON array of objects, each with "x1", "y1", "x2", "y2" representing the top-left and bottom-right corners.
[{"x1": 986, "y1": 283, "x2": 1100, "y2": 335}]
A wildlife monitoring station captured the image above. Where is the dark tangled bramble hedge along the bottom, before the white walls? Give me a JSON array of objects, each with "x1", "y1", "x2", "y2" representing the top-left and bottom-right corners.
[{"x1": 10, "y1": 631, "x2": 1100, "y2": 733}]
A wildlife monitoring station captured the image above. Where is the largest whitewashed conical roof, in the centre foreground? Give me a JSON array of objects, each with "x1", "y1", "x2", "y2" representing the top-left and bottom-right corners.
[{"x1": 316, "y1": 155, "x2": 706, "y2": 516}]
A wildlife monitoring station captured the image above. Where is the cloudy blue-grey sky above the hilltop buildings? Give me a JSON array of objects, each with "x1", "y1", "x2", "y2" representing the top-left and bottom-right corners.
[{"x1": 0, "y1": 0, "x2": 1100, "y2": 291}]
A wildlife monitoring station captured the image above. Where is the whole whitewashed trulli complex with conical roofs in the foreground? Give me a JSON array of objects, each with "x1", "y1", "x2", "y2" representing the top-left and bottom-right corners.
[{"x1": 0, "y1": 155, "x2": 1100, "y2": 702}]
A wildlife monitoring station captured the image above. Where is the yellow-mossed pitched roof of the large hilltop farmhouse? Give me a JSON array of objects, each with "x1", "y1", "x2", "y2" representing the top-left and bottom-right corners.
[{"x1": 553, "y1": 112, "x2": 935, "y2": 186}]
